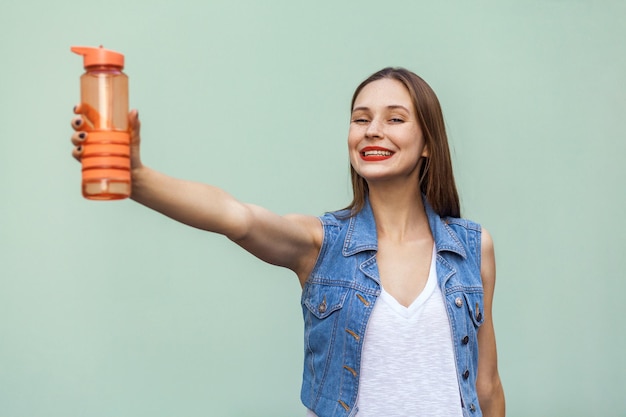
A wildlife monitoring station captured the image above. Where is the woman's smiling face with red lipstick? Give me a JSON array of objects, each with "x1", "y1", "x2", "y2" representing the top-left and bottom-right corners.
[{"x1": 348, "y1": 78, "x2": 428, "y2": 185}]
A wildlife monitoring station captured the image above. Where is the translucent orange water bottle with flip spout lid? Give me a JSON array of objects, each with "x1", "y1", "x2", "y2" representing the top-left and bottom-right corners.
[{"x1": 71, "y1": 46, "x2": 131, "y2": 200}]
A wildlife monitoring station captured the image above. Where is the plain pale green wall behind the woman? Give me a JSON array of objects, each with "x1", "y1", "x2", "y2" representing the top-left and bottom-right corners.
[{"x1": 0, "y1": 0, "x2": 626, "y2": 417}]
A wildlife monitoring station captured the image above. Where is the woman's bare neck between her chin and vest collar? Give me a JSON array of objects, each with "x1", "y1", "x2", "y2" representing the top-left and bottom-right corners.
[{"x1": 369, "y1": 180, "x2": 432, "y2": 242}]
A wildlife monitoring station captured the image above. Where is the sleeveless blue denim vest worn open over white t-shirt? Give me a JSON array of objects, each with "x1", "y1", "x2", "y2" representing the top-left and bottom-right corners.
[{"x1": 301, "y1": 199, "x2": 484, "y2": 417}]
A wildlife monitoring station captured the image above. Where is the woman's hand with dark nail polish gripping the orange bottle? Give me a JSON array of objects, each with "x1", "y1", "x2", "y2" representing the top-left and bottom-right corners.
[{"x1": 72, "y1": 104, "x2": 143, "y2": 174}]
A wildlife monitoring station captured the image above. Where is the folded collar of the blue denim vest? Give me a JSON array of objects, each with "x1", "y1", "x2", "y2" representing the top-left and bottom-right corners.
[{"x1": 342, "y1": 194, "x2": 467, "y2": 258}]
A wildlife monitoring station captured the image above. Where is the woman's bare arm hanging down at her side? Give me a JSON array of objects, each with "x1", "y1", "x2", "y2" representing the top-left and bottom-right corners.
[{"x1": 476, "y1": 229, "x2": 505, "y2": 417}]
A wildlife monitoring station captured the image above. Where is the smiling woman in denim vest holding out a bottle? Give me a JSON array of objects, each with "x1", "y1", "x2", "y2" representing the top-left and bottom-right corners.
[{"x1": 72, "y1": 68, "x2": 504, "y2": 417}]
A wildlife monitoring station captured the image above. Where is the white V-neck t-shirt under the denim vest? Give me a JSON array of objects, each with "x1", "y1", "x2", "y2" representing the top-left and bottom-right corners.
[{"x1": 307, "y1": 245, "x2": 463, "y2": 417}]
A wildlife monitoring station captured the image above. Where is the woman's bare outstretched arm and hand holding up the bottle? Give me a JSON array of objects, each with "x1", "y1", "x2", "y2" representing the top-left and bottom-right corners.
[{"x1": 72, "y1": 106, "x2": 323, "y2": 283}]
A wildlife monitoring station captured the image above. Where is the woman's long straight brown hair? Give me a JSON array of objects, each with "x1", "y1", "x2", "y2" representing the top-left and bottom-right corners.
[{"x1": 347, "y1": 67, "x2": 461, "y2": 217}]
